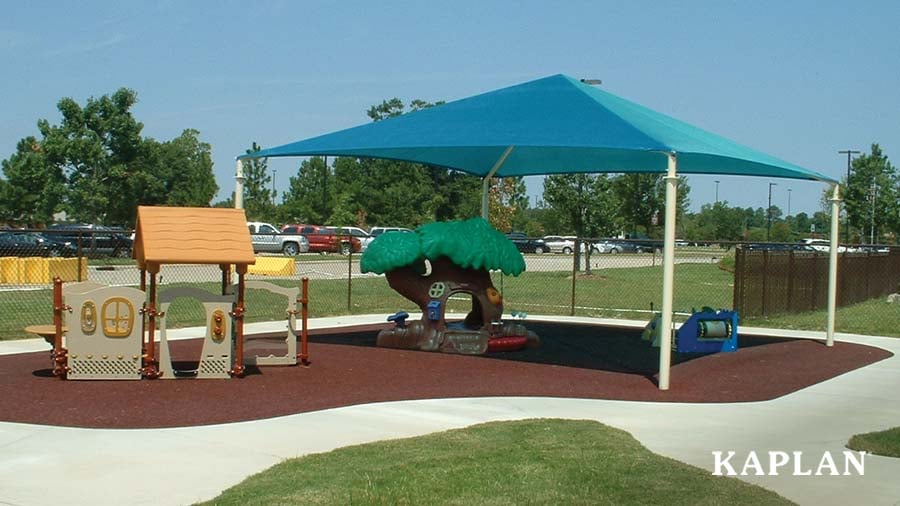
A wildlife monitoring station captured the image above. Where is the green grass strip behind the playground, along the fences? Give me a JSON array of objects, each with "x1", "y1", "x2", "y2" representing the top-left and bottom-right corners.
[{"x1": 0, "y1": 264, "x2": 900, "y2": 340}]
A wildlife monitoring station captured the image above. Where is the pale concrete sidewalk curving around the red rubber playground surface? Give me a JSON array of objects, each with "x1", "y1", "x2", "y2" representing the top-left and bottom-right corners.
[{"x1": 0, "y1": 317, "x2": 900, "y2": 506}]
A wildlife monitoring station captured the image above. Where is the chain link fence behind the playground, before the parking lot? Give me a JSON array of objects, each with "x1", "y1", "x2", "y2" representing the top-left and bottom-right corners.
[{"x1": 0, "y1": 231, "x2": 900, "y2": 340}]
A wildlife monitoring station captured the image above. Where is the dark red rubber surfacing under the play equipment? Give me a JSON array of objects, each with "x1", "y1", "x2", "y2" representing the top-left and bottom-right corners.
[{"x1": 0, "y1": 322, "x2": 891, "y2": 428}]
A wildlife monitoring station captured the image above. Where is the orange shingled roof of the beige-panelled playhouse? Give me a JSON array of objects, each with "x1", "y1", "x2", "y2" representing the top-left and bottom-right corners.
[{"x1": 134, "y1": 206, "x2": 256, "y2": 268}]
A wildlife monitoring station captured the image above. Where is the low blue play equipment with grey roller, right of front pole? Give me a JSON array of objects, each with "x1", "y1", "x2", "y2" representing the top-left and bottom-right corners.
[{"x1": 675, "y1": 307, "x2": 738, "y2": 353}]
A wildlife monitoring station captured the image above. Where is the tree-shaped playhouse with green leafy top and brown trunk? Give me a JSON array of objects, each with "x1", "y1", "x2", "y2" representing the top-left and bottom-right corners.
[{"x1": 360, "y1": 218, "x2": 538, "y2": 355}]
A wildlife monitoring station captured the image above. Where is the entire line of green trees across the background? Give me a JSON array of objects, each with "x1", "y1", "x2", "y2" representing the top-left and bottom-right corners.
[{"x1": 0, "y1": 88, "x2": 900, "y2": 242}]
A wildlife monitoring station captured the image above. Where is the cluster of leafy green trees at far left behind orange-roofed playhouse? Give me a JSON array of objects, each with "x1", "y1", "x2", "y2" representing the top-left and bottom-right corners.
[{"x1": 0, "y1": 88, "x2": 218, "y2": 225}]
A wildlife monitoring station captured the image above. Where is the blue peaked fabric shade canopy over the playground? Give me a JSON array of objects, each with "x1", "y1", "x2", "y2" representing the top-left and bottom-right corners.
[{"x1": 238, "y1": 74, "x2": 836, "y2": 182}]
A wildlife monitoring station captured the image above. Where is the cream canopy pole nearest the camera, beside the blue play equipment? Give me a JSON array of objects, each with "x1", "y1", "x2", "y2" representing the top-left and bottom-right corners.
[{"x1": 659, "y1": 153, "x2": 678, "y2": 390}]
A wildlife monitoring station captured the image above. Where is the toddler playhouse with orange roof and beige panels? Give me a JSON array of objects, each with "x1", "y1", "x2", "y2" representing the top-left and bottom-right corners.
[{"x1": 52, "y1": 206, "x2": 309, "y2": 379}]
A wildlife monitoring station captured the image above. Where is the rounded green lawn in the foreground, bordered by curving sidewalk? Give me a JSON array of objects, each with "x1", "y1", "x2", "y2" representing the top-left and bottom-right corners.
[{"x1": 199, "y1": 420, "x2": 792, "y2": 505}]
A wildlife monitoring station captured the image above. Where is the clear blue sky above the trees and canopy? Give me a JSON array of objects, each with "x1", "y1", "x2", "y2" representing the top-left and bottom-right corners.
[{"x1": 0, "y1": 0, "x2": 900, "y2": 217}]
